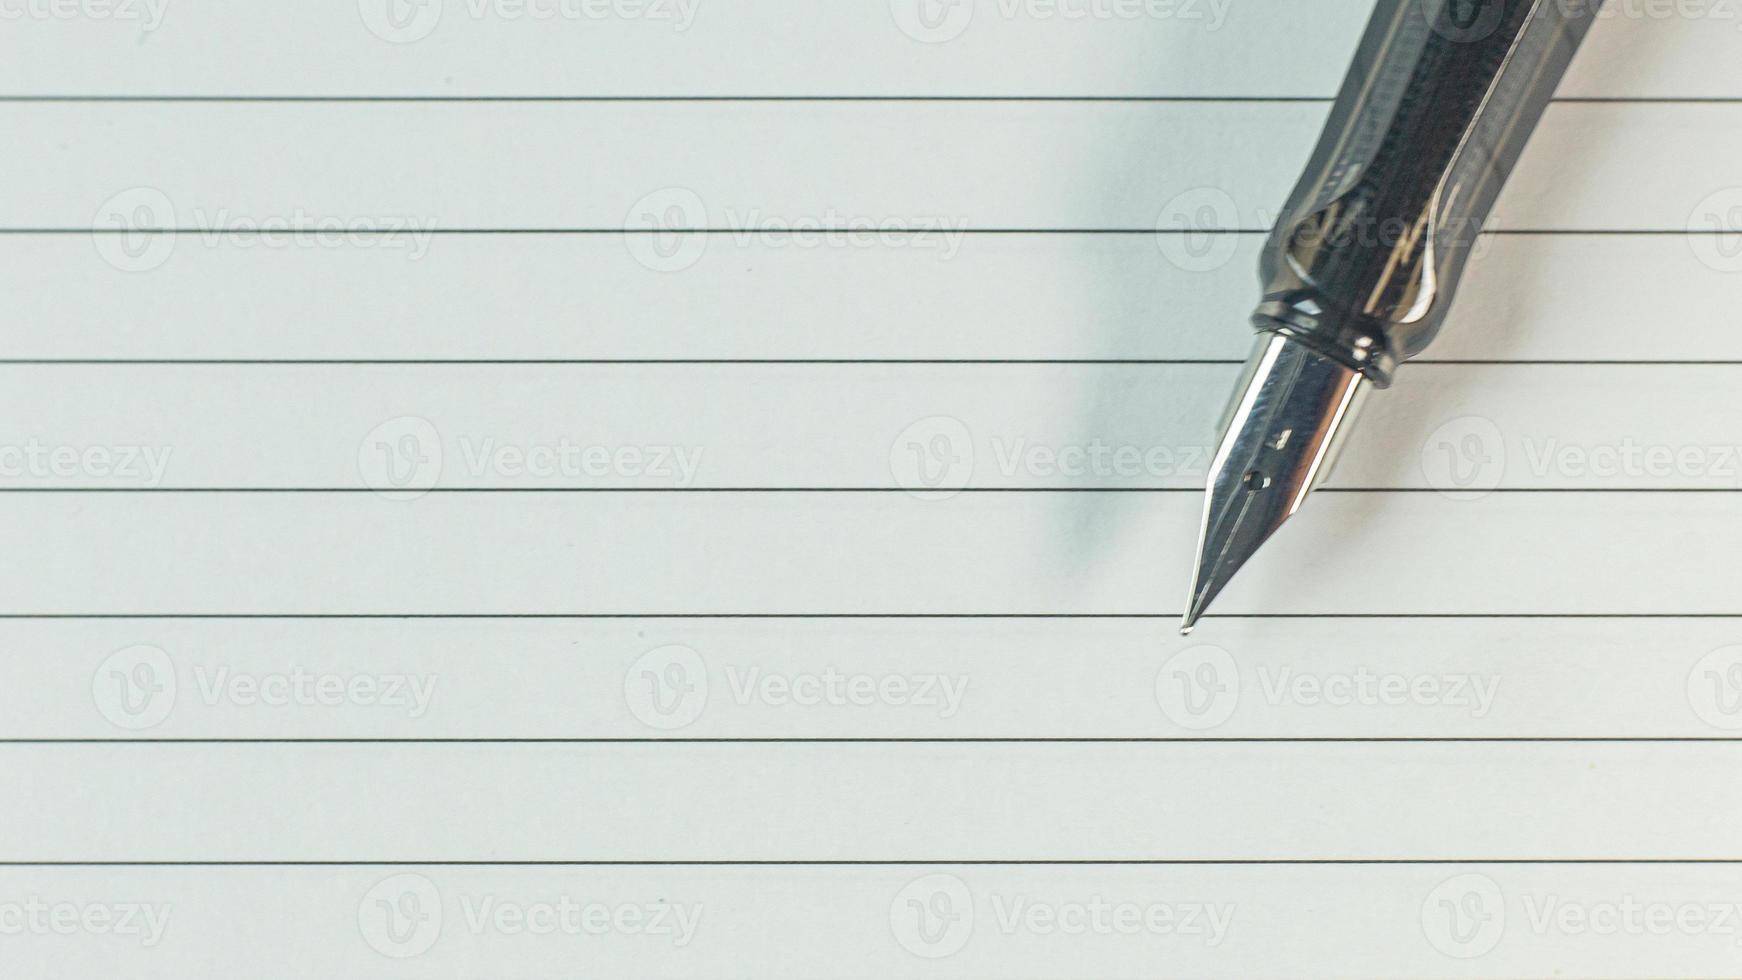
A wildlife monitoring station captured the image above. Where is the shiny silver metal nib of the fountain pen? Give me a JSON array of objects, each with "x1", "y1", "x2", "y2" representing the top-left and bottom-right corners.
[{"x1": 1179, "y1": 334, "x2": 1371, "y2": 634}]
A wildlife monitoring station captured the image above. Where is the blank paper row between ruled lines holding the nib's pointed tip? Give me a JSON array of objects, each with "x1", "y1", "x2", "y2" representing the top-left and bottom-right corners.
[{"x1": 0, "y1": 491, "x2": 1742, "y2": 616}]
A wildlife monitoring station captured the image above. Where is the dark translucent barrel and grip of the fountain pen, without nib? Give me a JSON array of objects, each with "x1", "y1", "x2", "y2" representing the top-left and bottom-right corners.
[{"x1": 1252, "y1": 0, "x2": 1601, "y2": 386}]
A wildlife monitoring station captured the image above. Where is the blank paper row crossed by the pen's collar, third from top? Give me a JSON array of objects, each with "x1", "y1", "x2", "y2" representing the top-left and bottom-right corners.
[{"x1": 13, "y1": 231, "x2": 1742, "y2": 362}]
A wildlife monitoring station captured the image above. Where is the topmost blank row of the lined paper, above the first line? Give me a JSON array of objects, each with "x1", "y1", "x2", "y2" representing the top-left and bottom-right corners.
[{"x1": 0, "y1": 0, "x2": 1742, "y2": 99}]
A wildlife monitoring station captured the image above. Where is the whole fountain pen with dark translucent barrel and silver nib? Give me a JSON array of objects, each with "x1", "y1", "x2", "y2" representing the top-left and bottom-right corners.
[{"x1": 1181, "y1": 0, "x2": 1601, "y2": 634}]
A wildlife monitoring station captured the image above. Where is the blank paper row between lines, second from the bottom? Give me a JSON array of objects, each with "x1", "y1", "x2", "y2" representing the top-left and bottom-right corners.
[{"x1": 7, "y1": 745, "x2": 1742, "y2": 862}]
